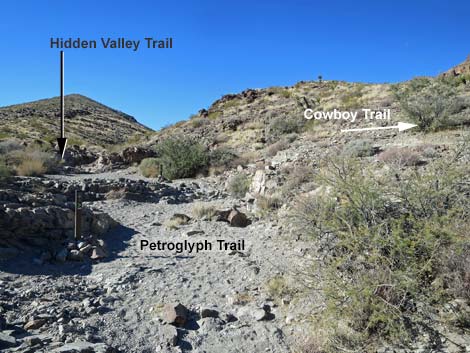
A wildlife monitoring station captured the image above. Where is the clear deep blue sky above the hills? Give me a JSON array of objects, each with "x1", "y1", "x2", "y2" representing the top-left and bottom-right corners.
[{"x1": 0, "y1": 0, "x2": 470, "y2": 129}]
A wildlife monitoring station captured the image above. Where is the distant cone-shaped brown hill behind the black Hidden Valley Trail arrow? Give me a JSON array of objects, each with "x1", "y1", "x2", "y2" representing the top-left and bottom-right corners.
[{"x1": 0, "y1": 94, "x2": 151, "y2": 146}]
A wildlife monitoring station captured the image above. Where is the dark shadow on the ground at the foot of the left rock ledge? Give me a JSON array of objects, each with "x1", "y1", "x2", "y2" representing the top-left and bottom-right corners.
[{"x1": 0, "y1": 225, "x2": 137, "y2": 276}]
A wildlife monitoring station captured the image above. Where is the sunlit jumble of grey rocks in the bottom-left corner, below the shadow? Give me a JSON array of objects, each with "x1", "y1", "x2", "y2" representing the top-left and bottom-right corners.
[{"x1": 0, "y1": 276, "x2": 119, "y2": 353}]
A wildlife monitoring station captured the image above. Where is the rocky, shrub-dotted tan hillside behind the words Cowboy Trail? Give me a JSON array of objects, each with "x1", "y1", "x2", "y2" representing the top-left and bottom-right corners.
[{"x1": 151, "y1": 71, "x2": 470, "y2": 157}]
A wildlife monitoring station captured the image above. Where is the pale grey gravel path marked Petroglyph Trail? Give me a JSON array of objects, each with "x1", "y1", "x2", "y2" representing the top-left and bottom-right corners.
[{"x1": 1, "y1": 171, "x2": 314, "y2": 353}]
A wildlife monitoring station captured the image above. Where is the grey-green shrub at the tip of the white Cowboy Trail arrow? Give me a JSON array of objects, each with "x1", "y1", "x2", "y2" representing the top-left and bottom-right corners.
[{"x1": 394, "y1": 78, "x2": 468, "y2": 132}]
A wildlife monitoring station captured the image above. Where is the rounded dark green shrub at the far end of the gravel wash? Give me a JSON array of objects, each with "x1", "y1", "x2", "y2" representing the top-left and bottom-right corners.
[{"x1": 156, "y1": 136, "x2": 209, "y2": 180}]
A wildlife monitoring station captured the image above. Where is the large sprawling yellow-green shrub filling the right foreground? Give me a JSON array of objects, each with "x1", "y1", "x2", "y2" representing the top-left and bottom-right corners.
[{"x1": 292, "y1": 148, "x2": 470, "y2": 351}]
